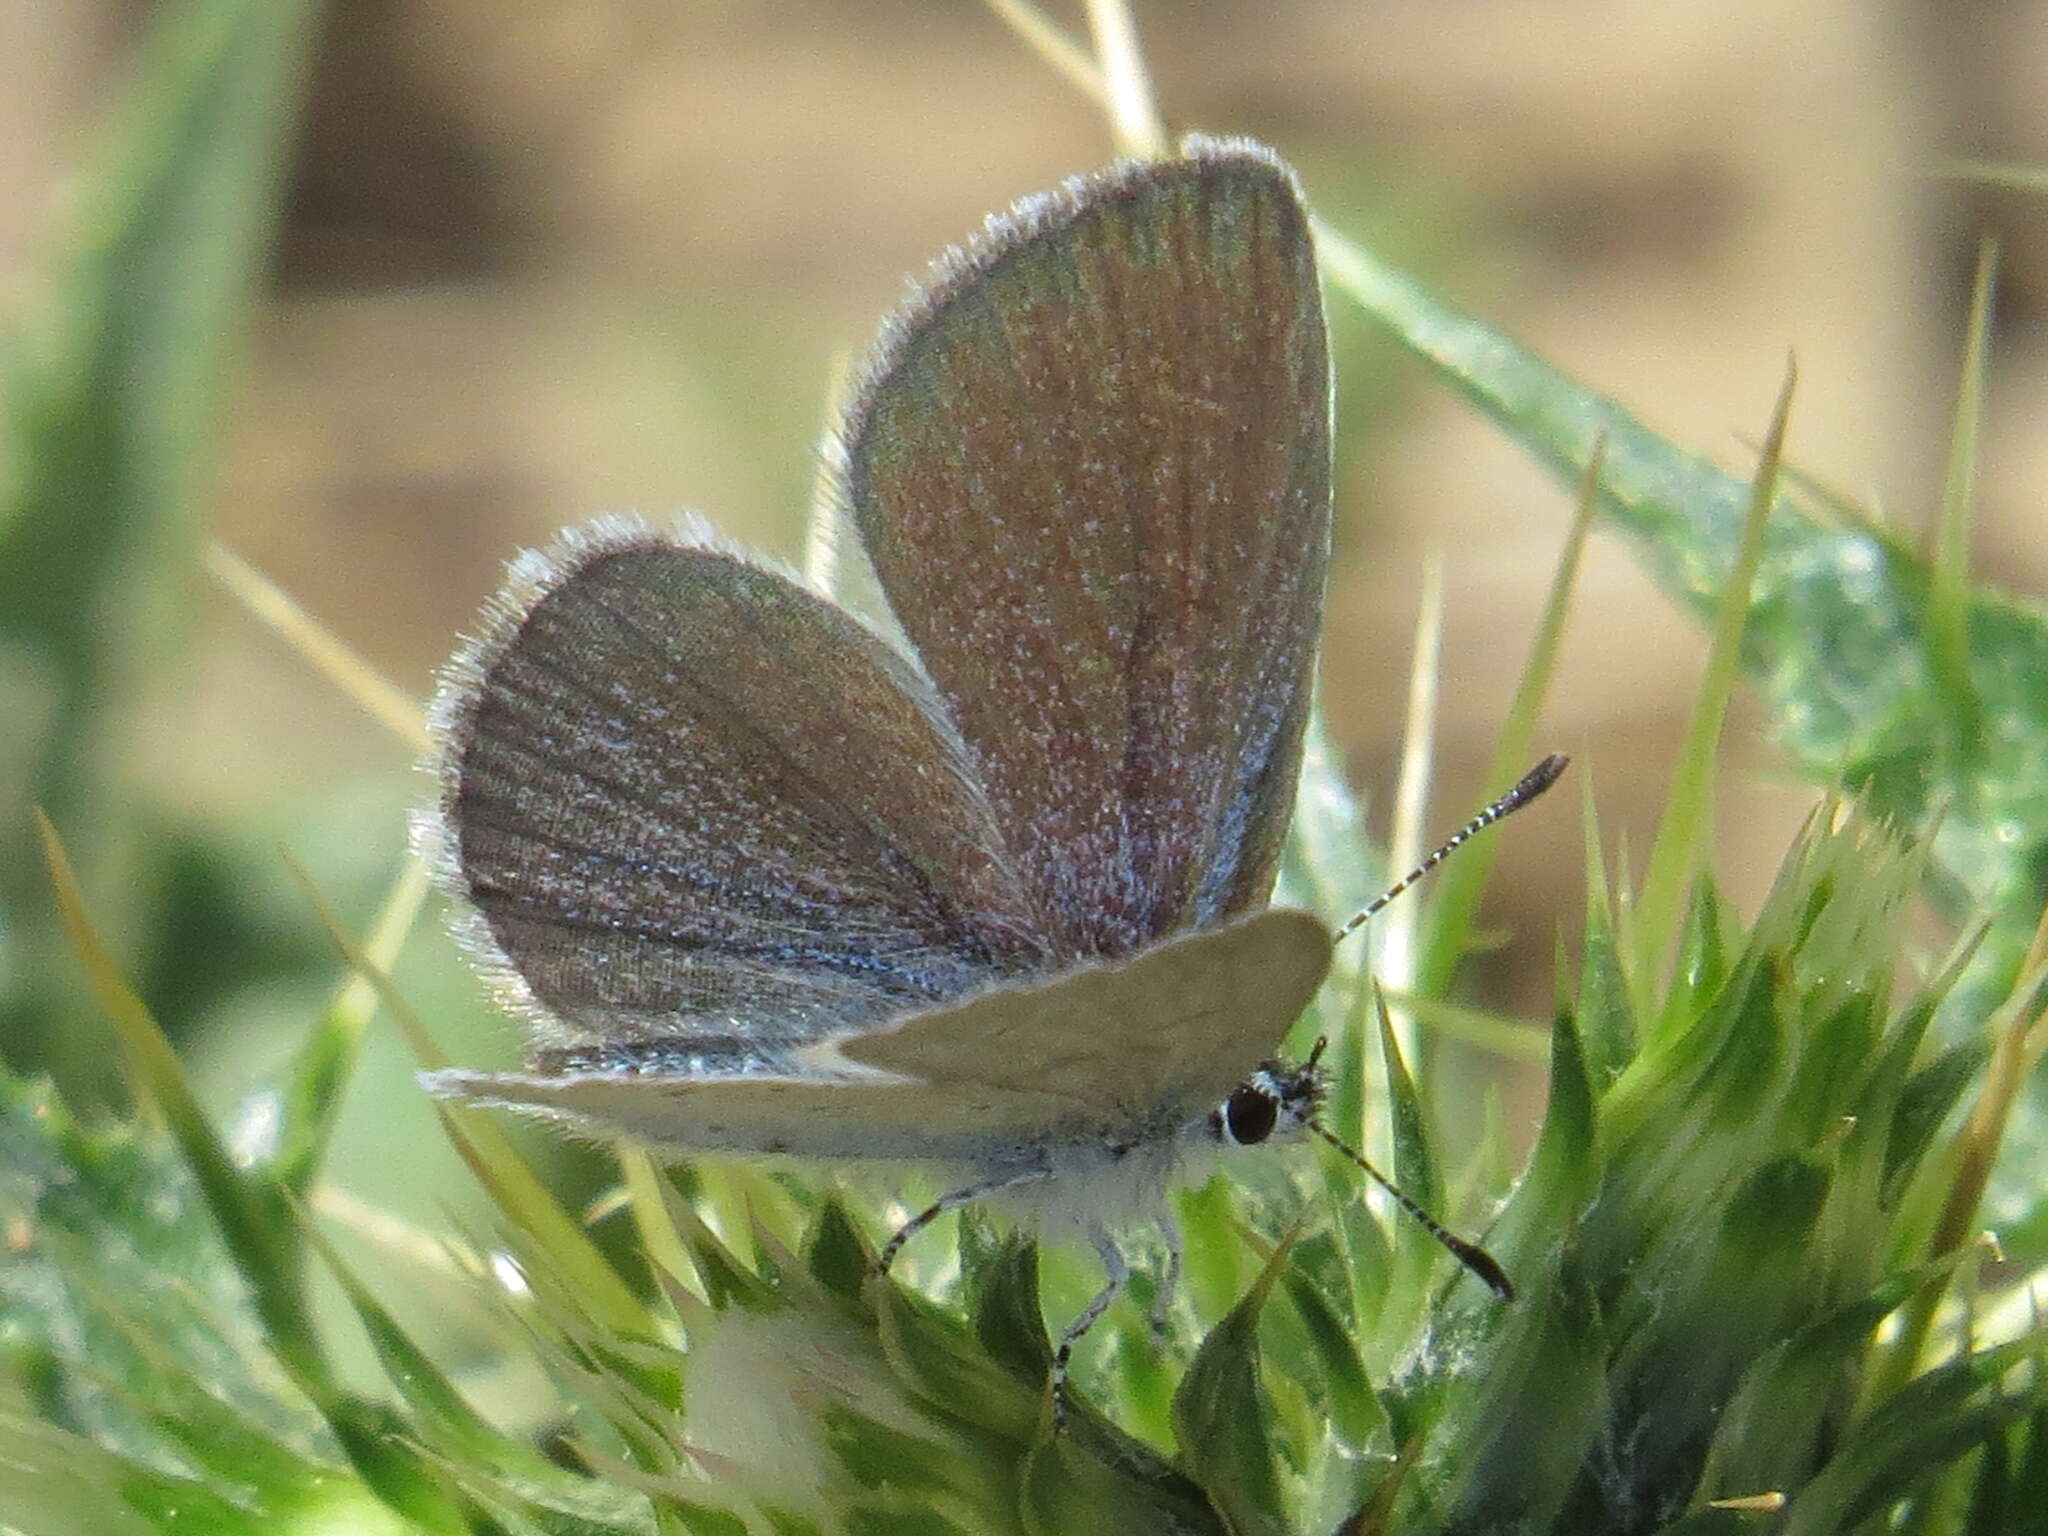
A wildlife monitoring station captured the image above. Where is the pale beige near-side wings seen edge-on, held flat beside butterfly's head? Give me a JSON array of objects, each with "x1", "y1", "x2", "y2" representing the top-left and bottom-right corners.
[{"x1": 422, "y1": 909, "x2": 1329, "y2": 1167}]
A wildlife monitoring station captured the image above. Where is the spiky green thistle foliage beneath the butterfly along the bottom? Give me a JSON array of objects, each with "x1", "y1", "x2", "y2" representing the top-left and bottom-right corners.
[{"x1": 0, "y1": 786, "x2": 2042, "y2": 1536}]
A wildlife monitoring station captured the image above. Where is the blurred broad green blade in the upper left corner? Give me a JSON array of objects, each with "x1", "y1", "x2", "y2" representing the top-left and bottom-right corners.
[{"x1": 0, "y1": 0, "x2": 319, "y2": 813}]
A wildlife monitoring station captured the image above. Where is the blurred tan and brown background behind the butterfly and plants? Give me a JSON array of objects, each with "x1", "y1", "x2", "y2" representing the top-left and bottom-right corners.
[{"x1": 0, "y1": 0, "x2": 2048, "y2": 1359}]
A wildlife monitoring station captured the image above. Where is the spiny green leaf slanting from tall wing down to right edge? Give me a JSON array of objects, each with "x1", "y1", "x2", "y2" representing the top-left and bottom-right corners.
[{"x1": 1317, "y1": 210, "x2": 2048, "y2": 1024}]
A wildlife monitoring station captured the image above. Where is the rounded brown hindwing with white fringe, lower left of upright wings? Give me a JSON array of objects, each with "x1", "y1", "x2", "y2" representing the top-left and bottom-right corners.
[{"x1": 424, "y1": 522, "x2": 1044, "y2": 1049}]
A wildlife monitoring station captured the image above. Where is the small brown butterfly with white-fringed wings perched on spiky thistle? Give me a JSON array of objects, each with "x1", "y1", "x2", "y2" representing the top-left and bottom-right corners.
[{"x1": 420, "y1": 137, "x2": 1554, "y2": 1417}]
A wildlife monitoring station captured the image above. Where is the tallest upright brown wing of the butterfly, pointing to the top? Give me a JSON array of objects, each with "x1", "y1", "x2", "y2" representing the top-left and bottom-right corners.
[{"x1": 838, "y1": 141, "x2": 1329, "y2": 956}]
